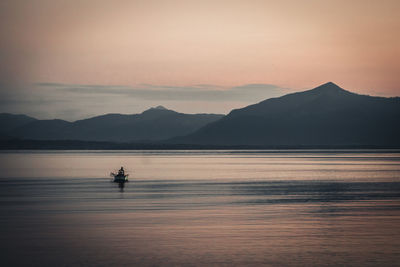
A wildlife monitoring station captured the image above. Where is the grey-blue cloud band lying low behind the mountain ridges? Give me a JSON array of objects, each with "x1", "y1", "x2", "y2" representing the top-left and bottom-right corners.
[{"x1": 0, "y1": 83, "x2": 291, "y2": 121}]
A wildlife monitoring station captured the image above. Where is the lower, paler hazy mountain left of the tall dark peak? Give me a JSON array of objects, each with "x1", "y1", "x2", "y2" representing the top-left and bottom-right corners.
[{"x1": 8, "y1": 106, "x2": 223, "y2": 142}]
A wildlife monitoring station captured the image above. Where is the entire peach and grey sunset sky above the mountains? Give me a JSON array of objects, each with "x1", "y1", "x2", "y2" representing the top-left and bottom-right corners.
[{"x1": 0, "y1": 0, "x2": 400, "y2": 120}]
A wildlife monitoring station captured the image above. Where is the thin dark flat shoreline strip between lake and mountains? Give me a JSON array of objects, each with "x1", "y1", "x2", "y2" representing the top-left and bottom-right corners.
[{"x1": 0, "y1": 139, "x2": 400, "y2": 150}]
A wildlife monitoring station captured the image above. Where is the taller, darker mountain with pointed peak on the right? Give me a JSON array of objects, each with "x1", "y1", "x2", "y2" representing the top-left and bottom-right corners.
[{"x1": 169, "y1": 82, "x2": 400, "y2": 146}]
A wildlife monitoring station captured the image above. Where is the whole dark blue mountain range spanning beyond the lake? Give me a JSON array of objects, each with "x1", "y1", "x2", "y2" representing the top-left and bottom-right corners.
[{"x1": 0, "y1": 82, "x2": 400, "y2": 147}]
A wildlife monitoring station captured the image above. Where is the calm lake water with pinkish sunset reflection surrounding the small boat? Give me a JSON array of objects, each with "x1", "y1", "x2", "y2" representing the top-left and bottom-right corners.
[{"x1": 0, "y1": 151, "x2": 400, "y2": 266}]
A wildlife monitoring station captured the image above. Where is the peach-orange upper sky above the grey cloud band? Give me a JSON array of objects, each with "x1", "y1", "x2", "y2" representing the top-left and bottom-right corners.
[{"x1": 1, "y1": 0, "x2": 400, "y2": 94}]
